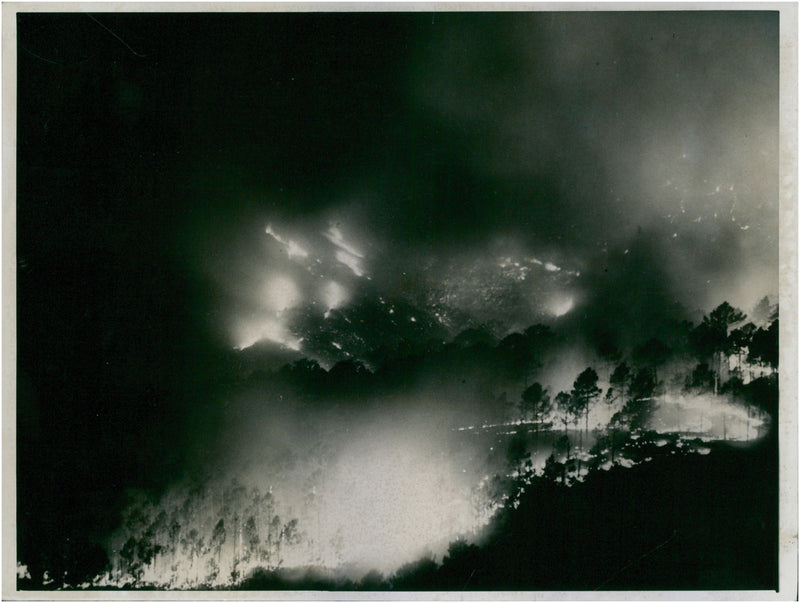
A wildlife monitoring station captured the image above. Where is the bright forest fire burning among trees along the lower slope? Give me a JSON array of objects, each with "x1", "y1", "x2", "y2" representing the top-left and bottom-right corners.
[{"x1": 93, "y1": 372, "x2": 770, "y2": 589}]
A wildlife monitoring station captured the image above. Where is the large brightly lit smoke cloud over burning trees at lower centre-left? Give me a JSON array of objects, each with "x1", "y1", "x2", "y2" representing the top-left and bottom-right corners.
[{"x1": 101, "y1": 381, "x2": 502, "y2": 587}]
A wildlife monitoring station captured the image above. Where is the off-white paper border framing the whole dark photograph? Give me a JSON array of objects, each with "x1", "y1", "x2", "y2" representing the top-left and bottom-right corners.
[{"x1": 2, "y1": 2, "x2": 800, "y2": 601}]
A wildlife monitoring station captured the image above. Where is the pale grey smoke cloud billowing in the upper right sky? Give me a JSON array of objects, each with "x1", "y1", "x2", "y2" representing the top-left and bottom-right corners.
[{"x1": 350, "y1": 12, "x2": 778, "y2": 316}]
